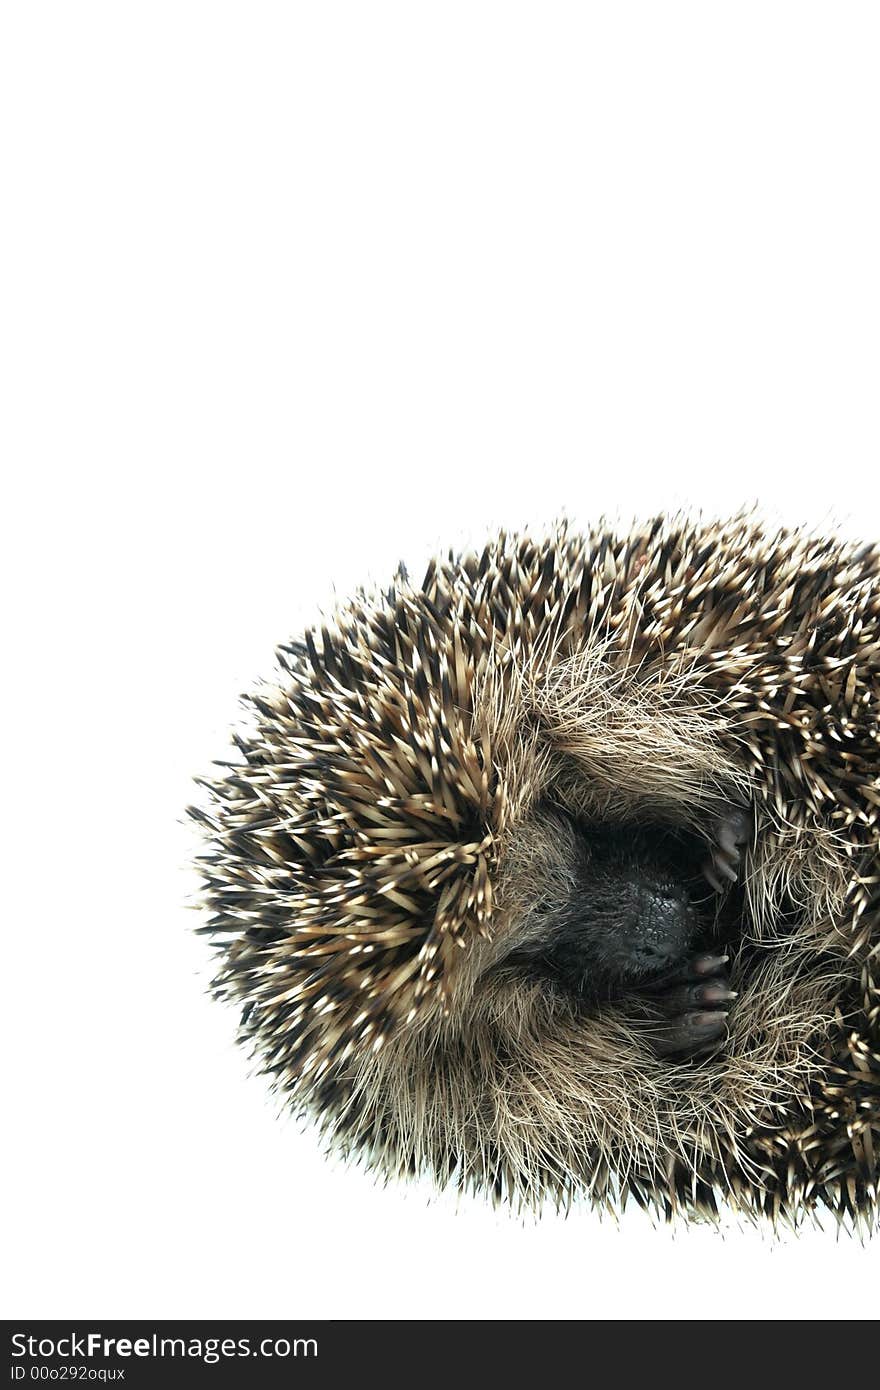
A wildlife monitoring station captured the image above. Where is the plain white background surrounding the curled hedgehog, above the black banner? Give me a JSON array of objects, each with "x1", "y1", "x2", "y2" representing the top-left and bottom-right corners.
[{"x1": 0, "y1": 0, "x2": 880, "y2": 1318}]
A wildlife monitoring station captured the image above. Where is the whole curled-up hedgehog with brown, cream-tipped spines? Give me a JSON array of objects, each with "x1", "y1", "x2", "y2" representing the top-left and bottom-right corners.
[{"x1": 192, "y1": 517, "x2": 880, "y2": 1229}]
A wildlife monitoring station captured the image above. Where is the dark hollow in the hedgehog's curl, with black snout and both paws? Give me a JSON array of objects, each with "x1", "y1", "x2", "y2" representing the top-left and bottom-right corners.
[{"x1": 489, "y1": 806, "x2": 751, "y2": 1056}]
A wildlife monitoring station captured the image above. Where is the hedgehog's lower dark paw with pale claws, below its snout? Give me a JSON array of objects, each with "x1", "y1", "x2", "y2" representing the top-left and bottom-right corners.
[{"x1": 651, "y1": 954, "x2": 737, "y2": 1059}]
